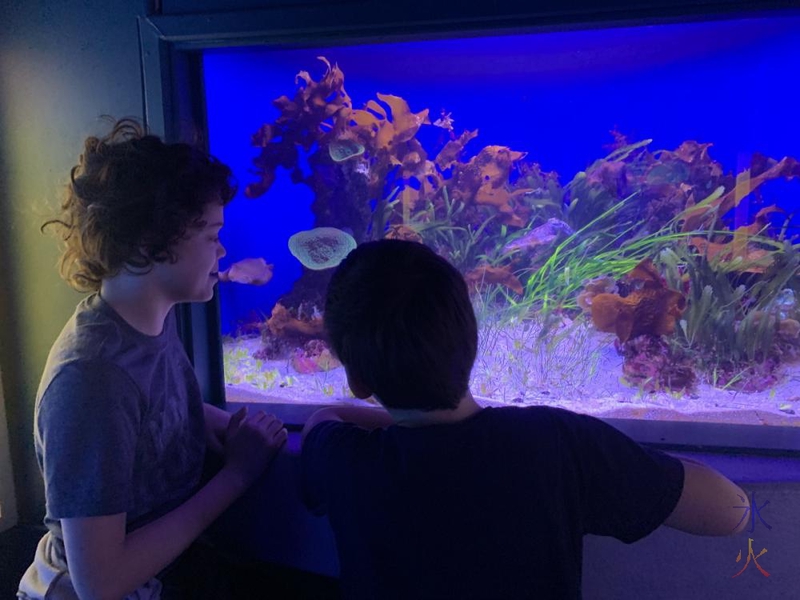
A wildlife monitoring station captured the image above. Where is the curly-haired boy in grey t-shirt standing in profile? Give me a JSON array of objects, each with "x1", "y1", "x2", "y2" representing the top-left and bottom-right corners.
[{"x1": 18, "y1": 120, "x2": 287, "y2": 599}]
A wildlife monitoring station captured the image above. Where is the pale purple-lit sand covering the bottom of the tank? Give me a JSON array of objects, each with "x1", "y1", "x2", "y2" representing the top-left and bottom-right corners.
[{"x1": 223, "y1": 324, "x2": 800, "y2": 426}]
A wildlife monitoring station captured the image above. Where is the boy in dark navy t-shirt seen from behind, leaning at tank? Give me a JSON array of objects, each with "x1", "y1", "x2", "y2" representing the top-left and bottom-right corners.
[{"x1": 302, "y1": 240, "x2": 745, "y2": 598}]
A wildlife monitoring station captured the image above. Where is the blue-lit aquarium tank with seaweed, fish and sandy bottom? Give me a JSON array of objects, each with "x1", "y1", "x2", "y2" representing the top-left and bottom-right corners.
[{"x1": 202, "y1": 15, "x2": 800, "y2": 426}]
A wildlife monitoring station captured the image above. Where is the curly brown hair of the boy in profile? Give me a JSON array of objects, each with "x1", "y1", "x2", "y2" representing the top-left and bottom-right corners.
[{"x1": 41, "y1": 119, "x2": 236, "y2": 291}]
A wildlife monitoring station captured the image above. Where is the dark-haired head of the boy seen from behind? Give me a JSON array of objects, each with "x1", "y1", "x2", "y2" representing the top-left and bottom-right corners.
[{"x1": 325, "y1": 240, "x2": 478, "y2": 410}]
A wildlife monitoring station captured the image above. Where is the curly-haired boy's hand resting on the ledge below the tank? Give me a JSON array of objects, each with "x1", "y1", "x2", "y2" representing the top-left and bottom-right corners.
[{"x1": 225, "y1": 406, "x2": 289, "y2": 486}]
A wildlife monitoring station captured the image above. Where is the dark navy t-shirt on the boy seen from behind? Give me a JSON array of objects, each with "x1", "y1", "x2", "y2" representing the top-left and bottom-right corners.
[{"x1": 302, "y1": 407, "x2": 683, "y2": 598}]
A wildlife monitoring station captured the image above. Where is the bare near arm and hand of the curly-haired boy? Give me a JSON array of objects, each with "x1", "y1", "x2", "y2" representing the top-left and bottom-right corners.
[{"x1": 61, "y1": 410, "x2": 286, "y2": 599}]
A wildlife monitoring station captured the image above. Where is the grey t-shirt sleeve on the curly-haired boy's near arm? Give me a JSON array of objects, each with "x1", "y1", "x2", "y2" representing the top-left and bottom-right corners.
[{"x1": 36, "y1": 362, "x2": 142, "y2": 519}]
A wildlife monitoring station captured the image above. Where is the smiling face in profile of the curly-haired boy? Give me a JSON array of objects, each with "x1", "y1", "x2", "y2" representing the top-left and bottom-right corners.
[{"x1": 155, "y1": 201, "x2": 225, "y2": 303}]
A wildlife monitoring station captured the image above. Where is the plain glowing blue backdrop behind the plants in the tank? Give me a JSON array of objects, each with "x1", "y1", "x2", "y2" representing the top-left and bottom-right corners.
[{"x1": 203, "y1": 17, "x2": 800, "y2": 334}]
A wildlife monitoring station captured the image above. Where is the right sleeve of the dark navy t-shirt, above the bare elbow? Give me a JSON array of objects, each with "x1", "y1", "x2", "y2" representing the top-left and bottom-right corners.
[{"x1": 557, "y1": 411, "x2": 684, "y2": 544}]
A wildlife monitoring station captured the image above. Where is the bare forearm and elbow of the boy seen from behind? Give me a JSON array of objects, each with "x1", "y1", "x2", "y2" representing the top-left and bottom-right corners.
[{"x1": 664, "y1": 457, "x2": 750, "y2": 535}]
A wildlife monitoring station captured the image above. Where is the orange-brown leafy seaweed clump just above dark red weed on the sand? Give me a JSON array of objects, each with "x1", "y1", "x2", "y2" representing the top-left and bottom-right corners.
[{"x1": 591, "y1": 259, "x2": 686, "y2": 342}]
